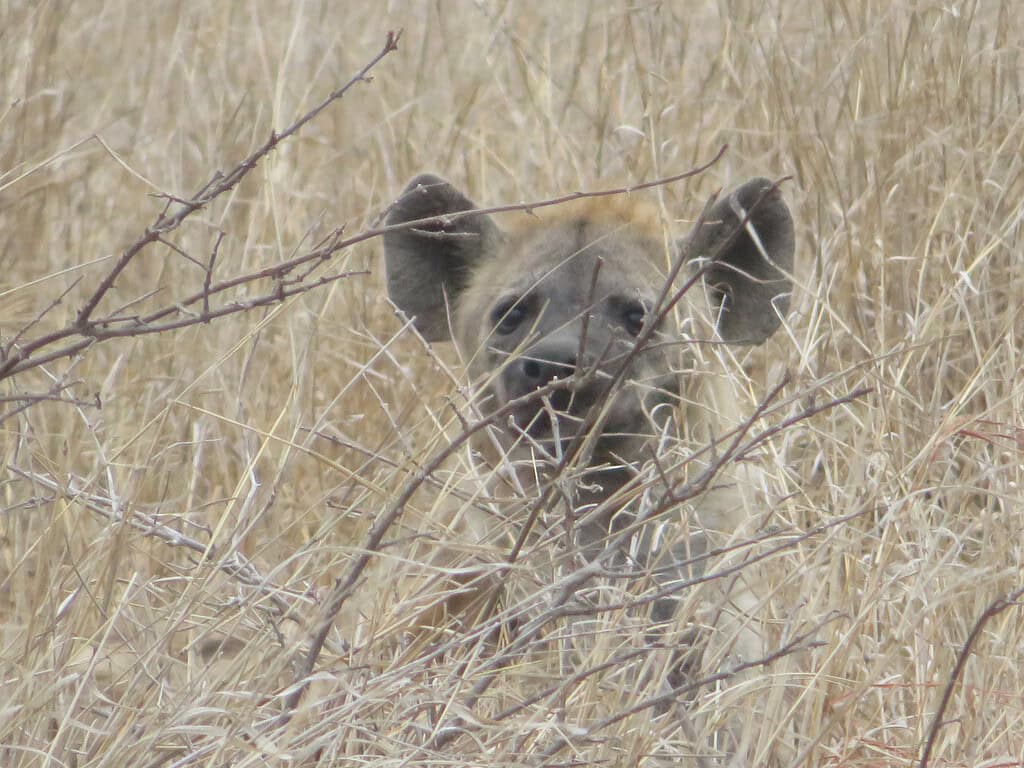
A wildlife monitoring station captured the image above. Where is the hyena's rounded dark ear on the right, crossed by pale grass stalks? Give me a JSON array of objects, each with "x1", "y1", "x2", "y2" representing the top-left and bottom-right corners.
[{"x1": 680, "y1": 178, "x2": 794, "y2": 344}]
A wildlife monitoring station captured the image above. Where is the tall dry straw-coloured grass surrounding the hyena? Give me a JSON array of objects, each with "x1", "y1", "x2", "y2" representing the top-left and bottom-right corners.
[{"x1": 0, "y1": 0, "x2": 1024, "y2": 768}]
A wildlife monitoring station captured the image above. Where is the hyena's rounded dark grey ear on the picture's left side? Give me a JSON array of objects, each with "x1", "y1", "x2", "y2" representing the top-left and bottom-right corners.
[{"x1": 384, "y1": 173, "x2": 501, "y2": 341}]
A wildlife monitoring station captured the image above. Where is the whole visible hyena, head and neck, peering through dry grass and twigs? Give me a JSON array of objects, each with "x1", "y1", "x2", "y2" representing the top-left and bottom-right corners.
[{"x1": 385, "y1": 175, "x2": 794, "y2": 653}]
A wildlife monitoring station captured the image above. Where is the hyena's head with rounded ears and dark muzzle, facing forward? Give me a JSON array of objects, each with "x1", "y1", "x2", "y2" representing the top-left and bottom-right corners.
[{"x1": 384, "y1": 174, "x2": 794, "y2": 490}]
